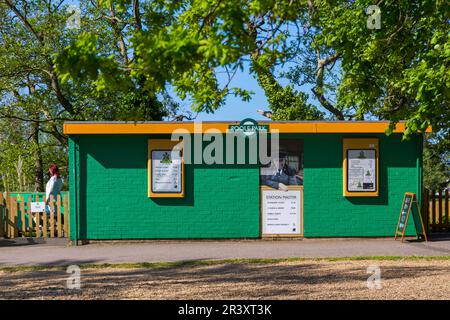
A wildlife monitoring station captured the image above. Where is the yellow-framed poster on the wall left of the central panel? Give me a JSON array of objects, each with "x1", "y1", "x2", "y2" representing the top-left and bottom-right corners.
[{"x1": 148, "y1": 139, "x2": 184, "y2": 197}]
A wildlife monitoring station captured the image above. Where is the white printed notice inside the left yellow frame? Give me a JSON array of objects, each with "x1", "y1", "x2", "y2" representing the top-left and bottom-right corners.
[{"x1": 152, "y1": 150, "x2": 182, "y2": 193}]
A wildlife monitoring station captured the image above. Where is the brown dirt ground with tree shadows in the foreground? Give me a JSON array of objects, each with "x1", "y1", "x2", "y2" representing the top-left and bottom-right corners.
[{"x1": 0, "y1": 260, "x2": 450, "y2": 299}]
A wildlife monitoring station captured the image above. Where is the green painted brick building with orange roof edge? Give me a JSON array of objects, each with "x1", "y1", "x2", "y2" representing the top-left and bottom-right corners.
[{"x1": 64, "y1": 122, "x2": 423, "y2": 240}]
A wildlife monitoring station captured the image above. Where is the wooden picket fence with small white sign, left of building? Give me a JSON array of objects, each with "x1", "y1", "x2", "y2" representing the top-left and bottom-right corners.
[{"x1": 0, "y1": 192, "x2": 70, "y2": 239}]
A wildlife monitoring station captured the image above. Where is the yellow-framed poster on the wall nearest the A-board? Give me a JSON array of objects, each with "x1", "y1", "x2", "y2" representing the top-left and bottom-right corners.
[{"x1": 343, "y1": 139, "x2": 379, "y2": 197}]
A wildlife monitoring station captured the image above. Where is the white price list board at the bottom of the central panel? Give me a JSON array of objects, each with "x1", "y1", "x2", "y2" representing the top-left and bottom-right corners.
[{"x1": 262, "y1": 190, "x2": 301, "y2": 235}]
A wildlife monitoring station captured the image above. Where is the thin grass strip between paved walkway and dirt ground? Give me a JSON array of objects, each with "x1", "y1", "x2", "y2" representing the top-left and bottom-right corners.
[{"x1": 0, "y1": 256, "x2": 450, "y2": 272}]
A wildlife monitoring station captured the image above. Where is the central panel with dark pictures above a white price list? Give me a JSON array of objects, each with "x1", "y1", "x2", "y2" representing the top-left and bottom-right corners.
[{"x1": 260, "y1": 139, "x2": 303, "y2": 237}]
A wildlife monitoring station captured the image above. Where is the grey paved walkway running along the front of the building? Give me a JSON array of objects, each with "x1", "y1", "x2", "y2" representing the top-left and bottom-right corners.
[{"x1": 0, "y1": 236, "x2": 450, "y2": 266}]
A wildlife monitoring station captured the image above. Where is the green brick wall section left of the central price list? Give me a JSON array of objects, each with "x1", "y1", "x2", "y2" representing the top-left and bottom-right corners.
[{"x1": 70, "y1": 135, "x2": 260, "y2": 239}]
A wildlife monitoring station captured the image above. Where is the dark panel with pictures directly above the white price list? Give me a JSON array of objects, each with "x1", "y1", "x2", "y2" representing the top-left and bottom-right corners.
[{"x1": 261, "y1": 139, "x2": 303, "y2": 191}]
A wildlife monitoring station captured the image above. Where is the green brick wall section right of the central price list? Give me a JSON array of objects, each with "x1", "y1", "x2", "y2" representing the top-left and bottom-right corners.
[{"x1": 303, "y1": 134, "x2": 421, "y2": 237}]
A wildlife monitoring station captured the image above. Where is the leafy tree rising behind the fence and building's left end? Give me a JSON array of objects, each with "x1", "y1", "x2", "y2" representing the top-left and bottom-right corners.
[{"x1": 0, "y1": 0, "x2": 178, "y2": 191}]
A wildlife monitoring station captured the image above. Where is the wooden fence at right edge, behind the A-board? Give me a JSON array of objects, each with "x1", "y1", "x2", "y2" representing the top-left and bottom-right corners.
[{"x1": 422, "y1": 189, "x2": 450, "y2": 232}]
